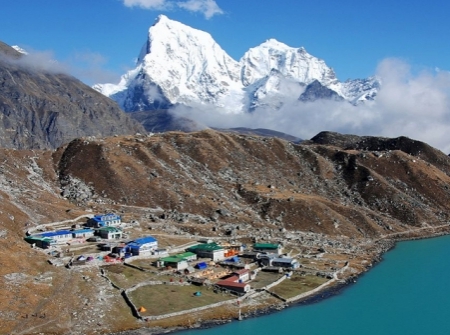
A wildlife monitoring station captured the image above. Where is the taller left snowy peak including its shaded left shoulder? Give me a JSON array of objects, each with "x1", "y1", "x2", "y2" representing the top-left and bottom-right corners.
[{"x1": 95, "y1": 15, "x2": 243, "y2": 111}]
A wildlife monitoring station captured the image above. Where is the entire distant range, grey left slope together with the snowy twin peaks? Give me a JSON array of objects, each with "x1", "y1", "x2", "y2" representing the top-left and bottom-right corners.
[{"x1": 0, "y1": 15, "x2": 380, "y2": 149}]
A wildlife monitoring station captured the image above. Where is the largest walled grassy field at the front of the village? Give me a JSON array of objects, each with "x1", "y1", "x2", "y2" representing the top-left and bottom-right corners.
[{"x1": 129, "y1": 285, "x2": 235, "y2": 316}]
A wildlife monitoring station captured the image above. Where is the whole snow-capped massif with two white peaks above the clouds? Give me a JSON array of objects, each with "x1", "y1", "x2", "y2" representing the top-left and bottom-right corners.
[{"x1": 94, "y1": 15, "x2": 379, "y2": 113}]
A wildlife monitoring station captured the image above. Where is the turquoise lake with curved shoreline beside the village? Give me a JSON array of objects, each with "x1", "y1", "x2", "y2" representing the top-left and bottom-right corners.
[{"x1": 179, "y1": 236, "x2": 450, "y2": 335}]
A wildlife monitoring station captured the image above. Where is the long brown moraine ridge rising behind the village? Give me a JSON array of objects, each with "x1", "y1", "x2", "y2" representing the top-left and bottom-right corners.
[{"x1": 59, "y1": 131, "x2": 450, "y2": 237}]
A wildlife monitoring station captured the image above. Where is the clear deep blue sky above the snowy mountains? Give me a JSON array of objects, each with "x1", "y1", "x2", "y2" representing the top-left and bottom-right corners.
[{"x1": 0, "y1": 0, "x2": 450, "y2": 84}]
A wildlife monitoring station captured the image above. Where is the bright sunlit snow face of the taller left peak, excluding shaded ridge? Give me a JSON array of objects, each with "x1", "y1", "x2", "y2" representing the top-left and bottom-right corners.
[{"x1": 140, "y1": 16, "x2": 244, "y2": 103}]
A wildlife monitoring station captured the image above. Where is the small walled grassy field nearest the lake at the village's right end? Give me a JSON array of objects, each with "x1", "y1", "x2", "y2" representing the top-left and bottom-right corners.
[{"x1": 270, "y1": 275, "x2": 328, "y2": 299}]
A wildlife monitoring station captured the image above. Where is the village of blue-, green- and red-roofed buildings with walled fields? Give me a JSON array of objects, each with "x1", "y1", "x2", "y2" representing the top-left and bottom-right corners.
[{"x1": 25, "y1": 213, "x2": 360, "y2": 321}]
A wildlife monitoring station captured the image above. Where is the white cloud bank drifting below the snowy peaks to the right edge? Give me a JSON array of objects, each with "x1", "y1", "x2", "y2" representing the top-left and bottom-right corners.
[{"x1": 174, "y1": 59, "x2": 450, "y2": 153}]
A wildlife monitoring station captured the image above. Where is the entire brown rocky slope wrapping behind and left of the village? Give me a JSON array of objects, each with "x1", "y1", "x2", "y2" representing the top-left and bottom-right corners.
[{"x1": 0, "y1": 130, "x2": 450, "y2": 334}]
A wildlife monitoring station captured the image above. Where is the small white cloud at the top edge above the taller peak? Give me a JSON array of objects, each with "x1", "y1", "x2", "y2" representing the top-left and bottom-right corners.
[{"x1": 123, "y1": 0, "x2": 223, "y2": 19}]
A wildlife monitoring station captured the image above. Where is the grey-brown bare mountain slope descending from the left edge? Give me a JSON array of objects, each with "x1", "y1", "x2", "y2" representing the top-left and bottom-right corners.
[{"x1": 0, "y1": 43, "x2": 145, "y2": 149}]
